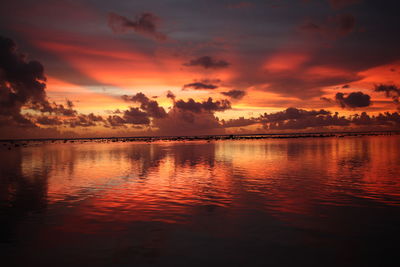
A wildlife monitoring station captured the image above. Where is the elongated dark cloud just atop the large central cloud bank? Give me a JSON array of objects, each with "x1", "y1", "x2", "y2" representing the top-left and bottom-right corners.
[{"x1": 175, "y1": 97, "x2": 231, "y2": 113}]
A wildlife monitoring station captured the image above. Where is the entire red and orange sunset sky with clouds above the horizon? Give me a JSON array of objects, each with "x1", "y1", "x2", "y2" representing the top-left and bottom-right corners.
[{"x1": 0, "y1": 0, "x2": 400, "y2": 139}]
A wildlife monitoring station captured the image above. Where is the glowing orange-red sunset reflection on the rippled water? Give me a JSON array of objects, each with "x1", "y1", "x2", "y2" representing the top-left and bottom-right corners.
[{"x1": 2, "y1": 136, "x2": 400, "y2": 236}]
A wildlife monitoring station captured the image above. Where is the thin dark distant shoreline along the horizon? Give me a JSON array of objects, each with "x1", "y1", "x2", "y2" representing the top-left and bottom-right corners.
[{"x1": 0, "y1": 131, "x2": 400, "y2": 143}]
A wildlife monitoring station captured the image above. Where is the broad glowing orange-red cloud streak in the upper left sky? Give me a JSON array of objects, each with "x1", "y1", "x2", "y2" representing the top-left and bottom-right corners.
[{"x1": 36, "y1": 38, "x2": 205, "y2": 92}]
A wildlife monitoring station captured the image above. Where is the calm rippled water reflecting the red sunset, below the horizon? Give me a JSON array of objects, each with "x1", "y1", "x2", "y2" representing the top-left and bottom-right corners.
[{"x1": 0, "y1": 136, "x2": 400, "y2": 266}]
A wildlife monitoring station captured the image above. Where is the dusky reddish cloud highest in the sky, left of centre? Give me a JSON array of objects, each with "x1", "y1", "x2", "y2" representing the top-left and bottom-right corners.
[{"x1": 108, "y1": 12, "x2": 167, "y2": 41}]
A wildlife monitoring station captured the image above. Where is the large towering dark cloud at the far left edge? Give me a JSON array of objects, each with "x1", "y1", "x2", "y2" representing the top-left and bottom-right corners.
[{"x1": 0, "y1": 37, "x2": 118, "y2": 138}]
